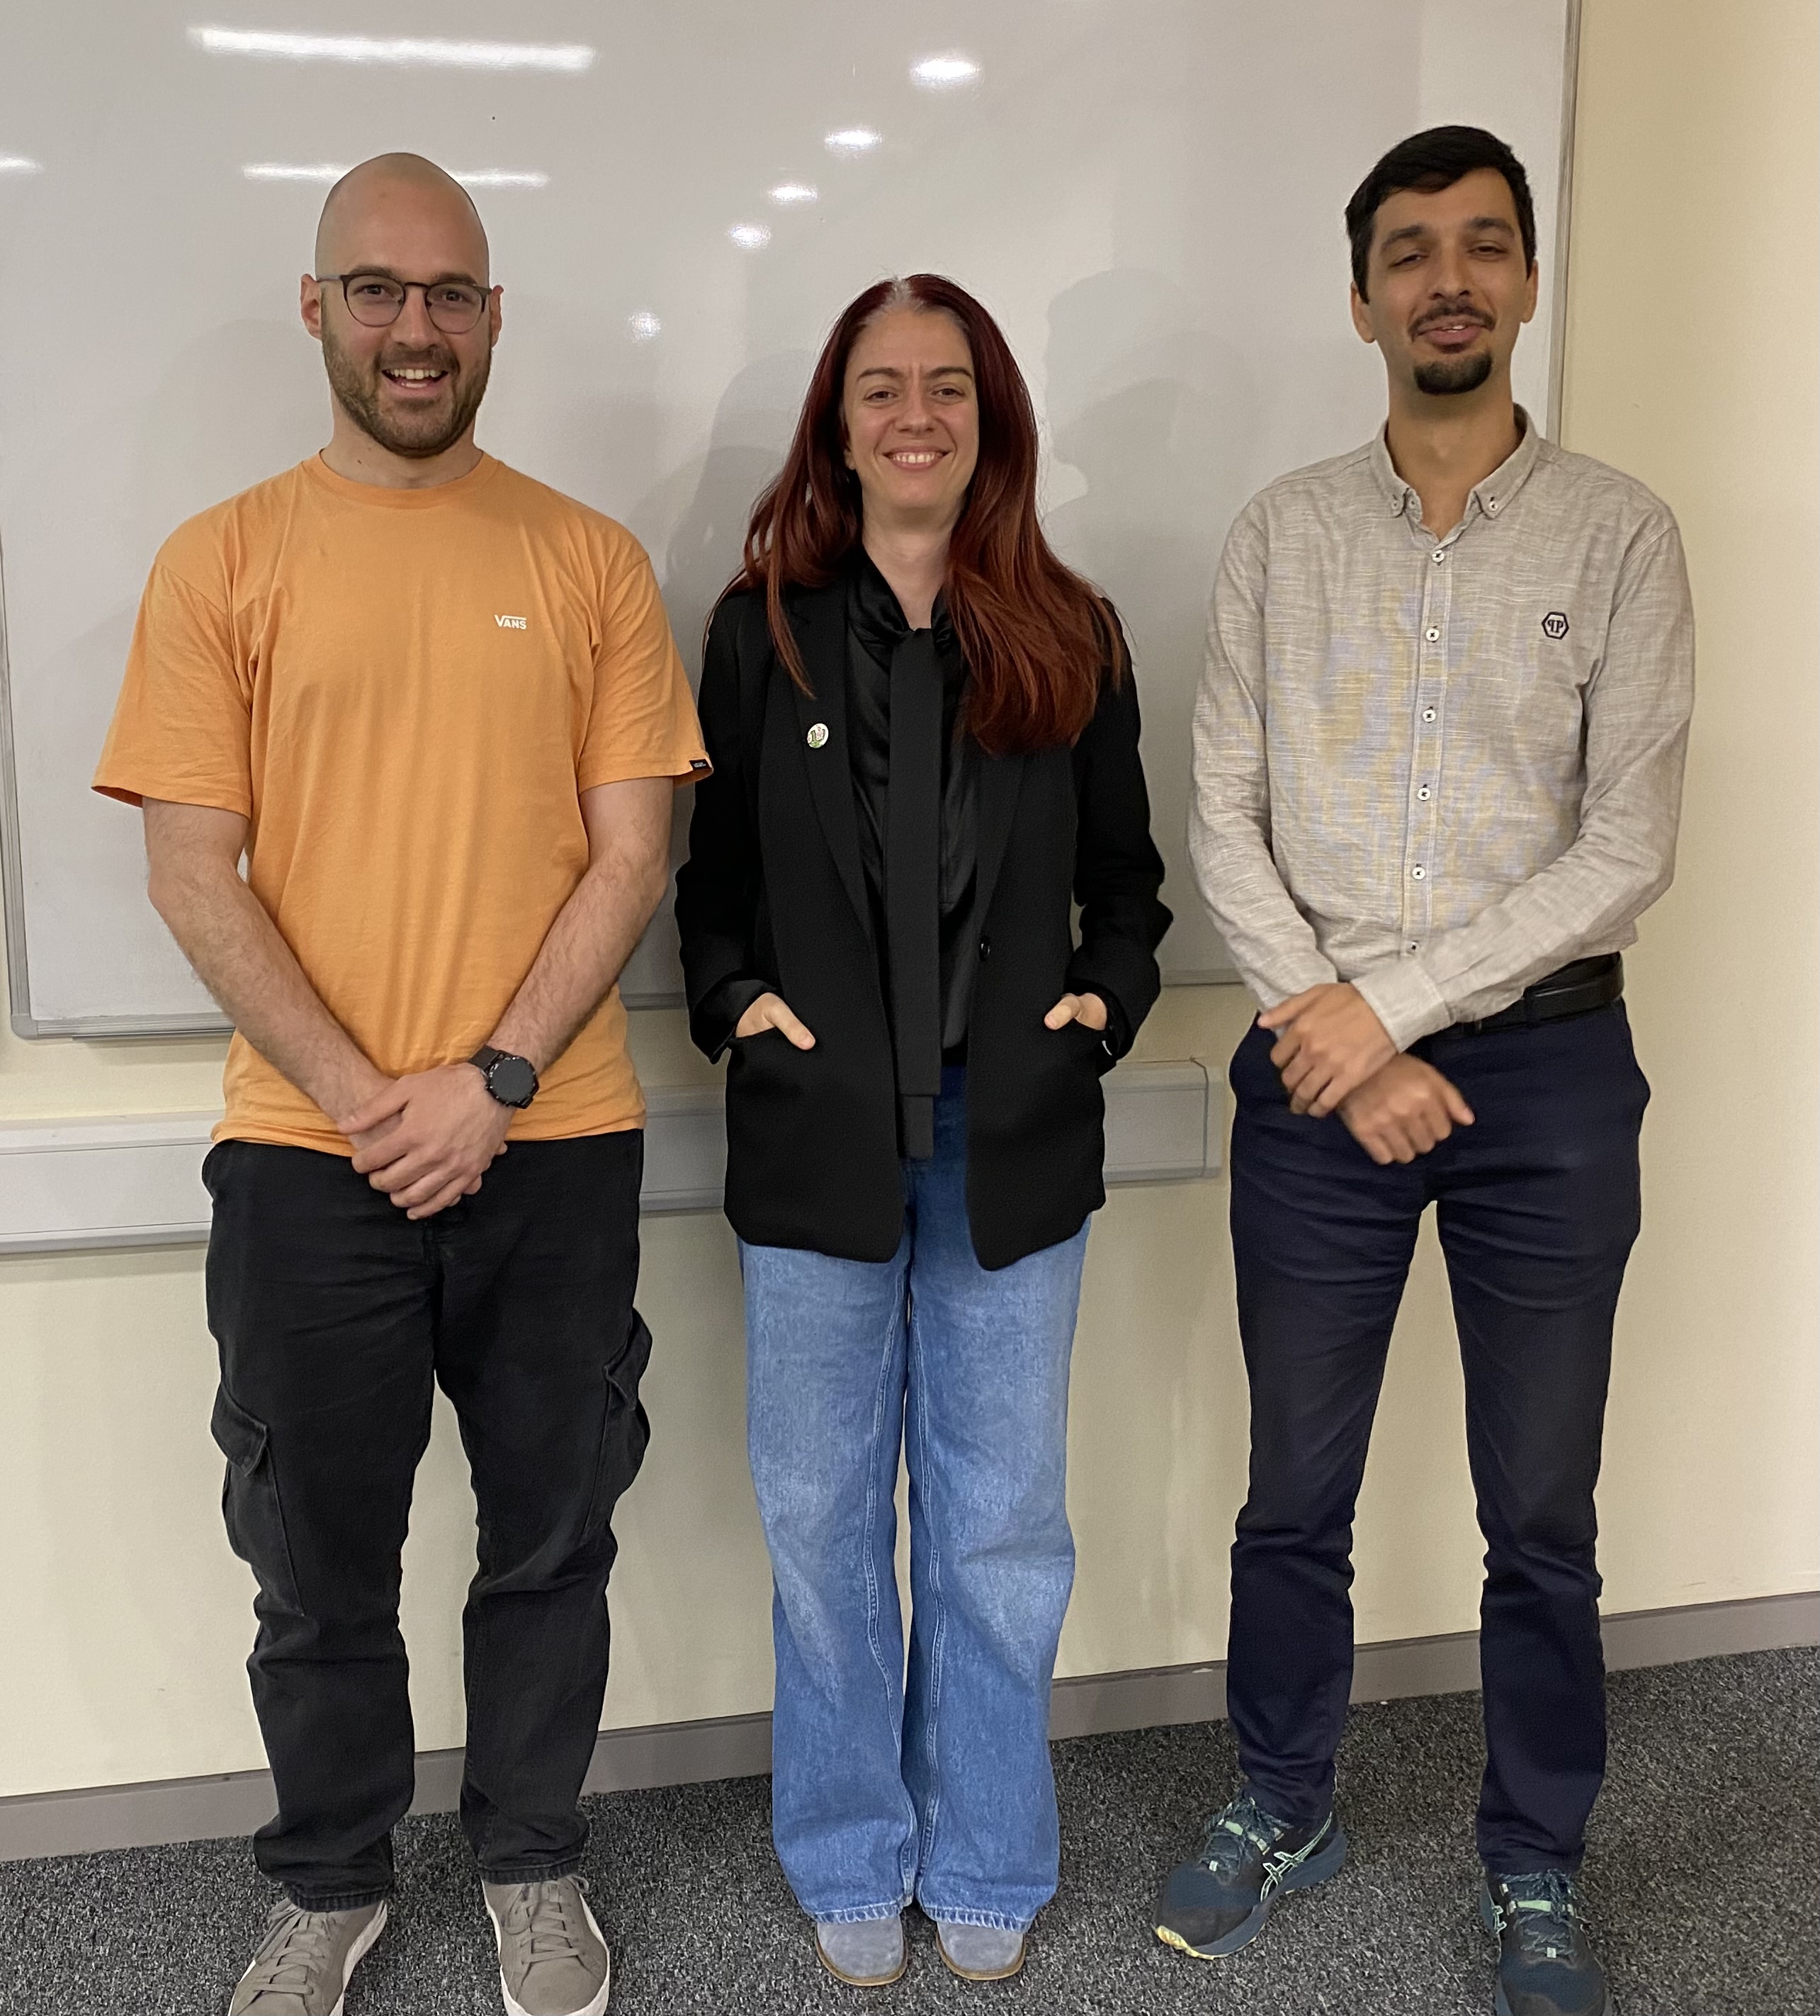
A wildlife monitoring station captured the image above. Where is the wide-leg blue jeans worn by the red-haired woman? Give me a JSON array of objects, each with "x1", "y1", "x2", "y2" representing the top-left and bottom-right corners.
[{"x1": 740, "y1": 1069, "x2": 1086, "y2": 1932}]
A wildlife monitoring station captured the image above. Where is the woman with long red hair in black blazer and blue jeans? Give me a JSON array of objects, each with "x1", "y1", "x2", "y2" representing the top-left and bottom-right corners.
[{"x1": 677, "y1": 274, "x2": 1169, "y2": 1986}]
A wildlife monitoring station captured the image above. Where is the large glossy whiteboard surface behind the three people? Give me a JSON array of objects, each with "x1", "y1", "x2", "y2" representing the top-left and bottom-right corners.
[{"x1": 0, "y1": 0, "x2": 1574, "y2": 1036}]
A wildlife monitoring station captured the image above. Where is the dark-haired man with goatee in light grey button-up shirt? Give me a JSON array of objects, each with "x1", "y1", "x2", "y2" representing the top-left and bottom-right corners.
[{"x1": 1157, "y1": 127, "x2": 1693, "y2": 2016}]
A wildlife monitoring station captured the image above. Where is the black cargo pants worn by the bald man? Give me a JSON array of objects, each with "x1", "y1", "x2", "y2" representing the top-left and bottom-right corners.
[{"x1": 203, "y1": 1131, "x2": 651, "y2": 1909}]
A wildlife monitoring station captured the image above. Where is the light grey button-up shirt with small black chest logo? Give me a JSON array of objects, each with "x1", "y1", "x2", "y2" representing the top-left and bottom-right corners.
[{"x1": 1189, "y1": 415, "x2": 1693, "y2": 1048}]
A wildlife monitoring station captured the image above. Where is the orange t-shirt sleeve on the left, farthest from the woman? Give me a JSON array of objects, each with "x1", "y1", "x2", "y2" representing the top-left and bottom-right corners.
[{"x1": 95, "y1": 554, "x2": 252, "y2": 818}]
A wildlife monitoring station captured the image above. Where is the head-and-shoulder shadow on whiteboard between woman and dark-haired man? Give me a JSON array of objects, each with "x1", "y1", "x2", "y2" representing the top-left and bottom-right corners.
[{"x1": 1044, "y1": 268, "x2": 1255, "y2": 978}]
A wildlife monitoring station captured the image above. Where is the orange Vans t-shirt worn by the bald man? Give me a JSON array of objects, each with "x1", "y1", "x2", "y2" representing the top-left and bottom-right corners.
[{"x1": 95, "y1": 456, "x2": 708, "y2": 1155}]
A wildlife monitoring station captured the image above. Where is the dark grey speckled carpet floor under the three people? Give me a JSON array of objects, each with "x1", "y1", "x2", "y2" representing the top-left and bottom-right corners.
[{"x1": 0, "y1": 1651, "x2": 1820, "y2": 2016}]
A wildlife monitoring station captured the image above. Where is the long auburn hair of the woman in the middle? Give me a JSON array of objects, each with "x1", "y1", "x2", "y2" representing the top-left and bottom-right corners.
[{"x1": 725, "y1": 272, "x2": 1124, "y2": 754}]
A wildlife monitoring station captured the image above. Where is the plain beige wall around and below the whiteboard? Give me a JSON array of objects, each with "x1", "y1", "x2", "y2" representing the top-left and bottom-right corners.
[{"x1": 0, "y1": 0, "x2": 1820, "y2": 1794}]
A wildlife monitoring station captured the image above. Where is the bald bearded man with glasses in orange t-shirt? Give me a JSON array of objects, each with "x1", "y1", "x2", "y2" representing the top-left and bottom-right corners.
[{"x1": 95, "y1": 155, "x2": 708, "y2": 2016}]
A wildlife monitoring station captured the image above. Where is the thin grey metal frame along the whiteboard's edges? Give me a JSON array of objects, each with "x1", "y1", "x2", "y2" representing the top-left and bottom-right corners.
[{"x1": 0, "y1": 0, "x2": 1582, "y2": 1042}]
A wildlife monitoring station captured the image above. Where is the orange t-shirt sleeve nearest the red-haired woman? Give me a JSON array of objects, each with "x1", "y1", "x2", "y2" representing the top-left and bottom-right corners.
[{"x1": 575, "y1": 534, "x2": 708, "y2": 790}]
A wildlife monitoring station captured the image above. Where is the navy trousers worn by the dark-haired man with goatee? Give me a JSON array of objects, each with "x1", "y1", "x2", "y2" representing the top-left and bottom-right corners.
[{"x1": 1228, "y1": 1002, "x2": 1649, "y2": 1875}]
